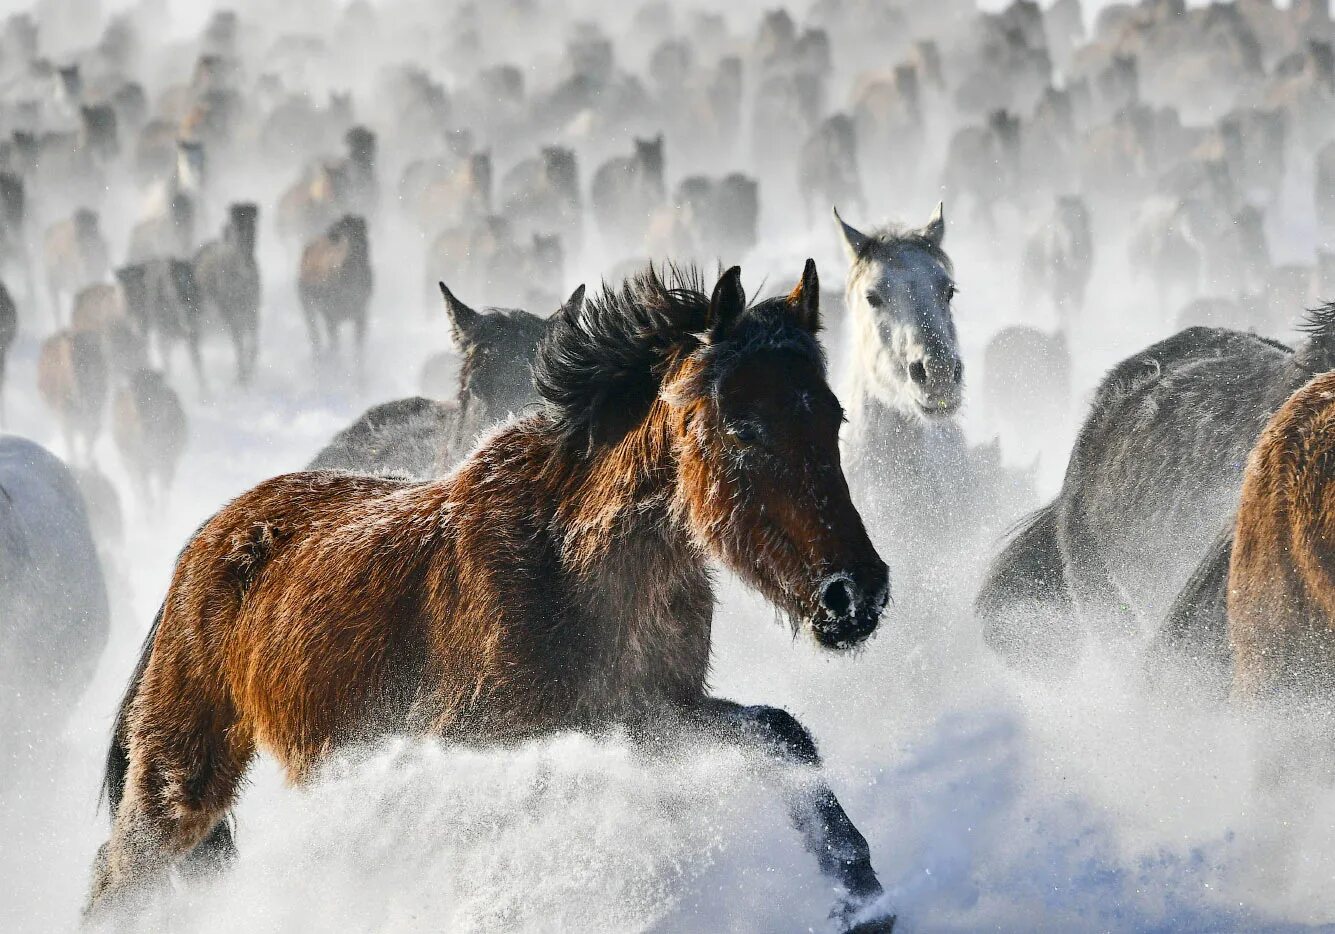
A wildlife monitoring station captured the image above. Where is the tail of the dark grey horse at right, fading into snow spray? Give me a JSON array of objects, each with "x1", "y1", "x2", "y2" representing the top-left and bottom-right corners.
[{"x1": 973, "y1": 498, "x2": 1080, "y2": 667}]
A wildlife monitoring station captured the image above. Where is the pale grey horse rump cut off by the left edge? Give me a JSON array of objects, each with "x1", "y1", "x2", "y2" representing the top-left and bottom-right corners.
[{"x1": 0, "y1": 435, "x2": 108, "y2": 757}]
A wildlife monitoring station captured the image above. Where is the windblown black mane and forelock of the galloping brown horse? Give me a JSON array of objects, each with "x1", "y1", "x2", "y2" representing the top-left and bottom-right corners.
[{"x1": 533, "y1": 264, "x2": 824, "y2": 450}]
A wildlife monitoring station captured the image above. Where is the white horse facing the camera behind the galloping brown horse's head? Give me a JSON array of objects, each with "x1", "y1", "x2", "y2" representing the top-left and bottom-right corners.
[{"x1": 834, "y1": 204, "x2": 1028, "y2": 595}]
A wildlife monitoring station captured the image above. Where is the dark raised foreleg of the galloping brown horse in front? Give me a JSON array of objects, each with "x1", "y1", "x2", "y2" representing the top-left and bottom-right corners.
[{"x1": 696, "y1": 698, "x2": 894, "y2": 934}]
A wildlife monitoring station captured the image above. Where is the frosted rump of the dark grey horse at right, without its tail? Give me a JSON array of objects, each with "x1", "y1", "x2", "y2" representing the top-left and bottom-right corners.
[{"x1": 1059, "y1": 327, "x2": 1292, "y2": 622}]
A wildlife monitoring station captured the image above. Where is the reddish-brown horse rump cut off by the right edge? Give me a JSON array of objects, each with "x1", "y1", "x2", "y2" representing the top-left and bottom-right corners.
[{"x1": 1228, "y1": 365, "x2": 1335, "y2": 699}]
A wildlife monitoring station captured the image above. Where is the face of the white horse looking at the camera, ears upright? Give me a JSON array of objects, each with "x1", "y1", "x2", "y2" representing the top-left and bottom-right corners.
[{"x1": 836, "y1": 208, "x2": 964, "y2": 419}]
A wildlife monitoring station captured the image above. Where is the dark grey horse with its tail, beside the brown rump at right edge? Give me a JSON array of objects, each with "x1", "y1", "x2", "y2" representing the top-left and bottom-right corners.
[{"x1": 975, "y1": 310, "x2": 1335, "y2": 675}]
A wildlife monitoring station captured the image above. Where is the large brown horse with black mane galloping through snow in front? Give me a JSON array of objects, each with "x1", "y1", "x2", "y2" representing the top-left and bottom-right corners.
[{"x1": 89, "y1": 260, "x2": 892, "y2": 931}]
